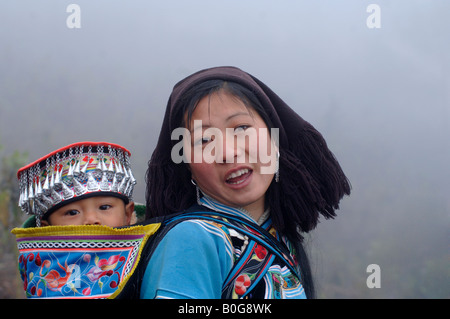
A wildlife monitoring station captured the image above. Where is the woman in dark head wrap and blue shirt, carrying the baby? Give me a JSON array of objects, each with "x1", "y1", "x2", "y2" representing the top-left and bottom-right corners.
[{"x1": 141, "y1": 67, "x2": 350, "y2": 298}]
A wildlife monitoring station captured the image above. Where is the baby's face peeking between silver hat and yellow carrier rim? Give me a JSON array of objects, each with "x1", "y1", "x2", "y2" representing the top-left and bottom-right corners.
[{"x1": 42, "y1": 196, "x2": 134, "y2": 227}]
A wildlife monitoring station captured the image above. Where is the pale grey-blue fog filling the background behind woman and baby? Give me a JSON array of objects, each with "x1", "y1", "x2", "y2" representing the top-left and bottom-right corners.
[{"x1": 0, "y1": 0, "x2": 450, "y2": 298}]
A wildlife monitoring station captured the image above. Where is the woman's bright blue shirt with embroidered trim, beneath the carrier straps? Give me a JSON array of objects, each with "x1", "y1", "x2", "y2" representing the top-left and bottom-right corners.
[{"x1": 141, "y1": 197, "x2": 306, "y2": 299}]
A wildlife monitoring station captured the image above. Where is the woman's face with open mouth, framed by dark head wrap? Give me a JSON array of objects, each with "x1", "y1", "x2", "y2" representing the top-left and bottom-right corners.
[{"x1": 187, "y1": 91, "x2": 276, "y2": 219}]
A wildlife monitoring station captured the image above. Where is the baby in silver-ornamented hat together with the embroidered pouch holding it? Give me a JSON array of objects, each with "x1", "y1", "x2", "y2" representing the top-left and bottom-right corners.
[{"x1": 12, "y1": 142, "x2": 155, "y2": 298}]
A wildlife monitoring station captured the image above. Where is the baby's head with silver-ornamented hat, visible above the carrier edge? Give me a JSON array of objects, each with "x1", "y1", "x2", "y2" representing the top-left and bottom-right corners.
[{"x1": 17, "y1": 142, "x2": 136, "y2": 227}]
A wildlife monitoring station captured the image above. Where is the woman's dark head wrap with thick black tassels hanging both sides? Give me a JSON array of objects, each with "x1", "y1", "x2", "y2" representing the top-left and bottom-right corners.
[{"x1": 146, "y1": 67, "x2": 350, "y2": 234}]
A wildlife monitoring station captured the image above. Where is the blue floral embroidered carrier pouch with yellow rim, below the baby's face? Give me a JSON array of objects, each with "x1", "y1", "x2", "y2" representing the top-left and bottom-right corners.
[{"x1": 11, "y1": 225, "x2": 158, "y2": 298}]
